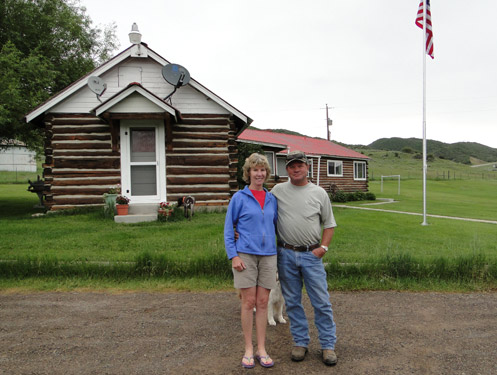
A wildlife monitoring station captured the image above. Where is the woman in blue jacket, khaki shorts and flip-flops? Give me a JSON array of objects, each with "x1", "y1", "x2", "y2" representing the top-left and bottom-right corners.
[{"x1": 224, "y1": 153, "x2": 278, "y2": 368}]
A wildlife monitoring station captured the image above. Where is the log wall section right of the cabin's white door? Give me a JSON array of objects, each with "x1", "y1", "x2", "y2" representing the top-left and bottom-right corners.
[{"x1": 166, "y1": 114, "x2": 238, "y2": 206}]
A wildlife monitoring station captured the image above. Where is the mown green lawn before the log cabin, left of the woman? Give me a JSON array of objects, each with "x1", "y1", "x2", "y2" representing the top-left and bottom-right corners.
[{"x1": 0, "y1": 185, "x2": 224, "y2": 261}]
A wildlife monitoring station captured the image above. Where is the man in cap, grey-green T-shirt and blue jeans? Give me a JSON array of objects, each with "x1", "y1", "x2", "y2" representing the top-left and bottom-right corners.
[{"x1": 271, "y1": 151, "x2": 337, "y2": 366}]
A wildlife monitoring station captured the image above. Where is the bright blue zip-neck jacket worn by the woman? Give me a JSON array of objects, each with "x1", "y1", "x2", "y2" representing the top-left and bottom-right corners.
[{"x1": 224, "y1": 186, "x2": 278, "y2": 259}]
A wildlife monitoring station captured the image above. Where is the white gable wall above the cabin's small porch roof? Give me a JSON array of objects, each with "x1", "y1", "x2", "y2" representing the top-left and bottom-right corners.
[{"x1": 49, "y1": 58, "x2": 229, "y2": 114}]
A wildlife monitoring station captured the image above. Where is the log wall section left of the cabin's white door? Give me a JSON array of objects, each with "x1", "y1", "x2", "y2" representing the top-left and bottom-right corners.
[{"x1": 43, "y1": 114, "x2": 121, "y2": 210}]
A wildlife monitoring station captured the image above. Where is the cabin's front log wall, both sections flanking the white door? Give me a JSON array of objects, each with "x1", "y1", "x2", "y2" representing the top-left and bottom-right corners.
[{"x1": 43, "y1": 114, "x2": 238, "y2": 210}]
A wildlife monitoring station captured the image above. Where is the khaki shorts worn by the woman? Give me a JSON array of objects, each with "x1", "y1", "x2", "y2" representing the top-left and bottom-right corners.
[{"x1": 232, "y1": 253, "x2": 277, "y2": 289}]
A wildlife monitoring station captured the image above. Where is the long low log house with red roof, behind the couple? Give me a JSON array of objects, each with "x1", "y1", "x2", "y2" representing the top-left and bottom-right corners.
[{"x1": 237, "y1": 128, "x2": 369, "y2": 192}]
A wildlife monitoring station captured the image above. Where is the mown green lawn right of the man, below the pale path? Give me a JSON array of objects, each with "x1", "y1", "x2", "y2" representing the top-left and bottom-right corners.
[{"x1": 332, "y1": 208, "x2": 497, "y2": 262}]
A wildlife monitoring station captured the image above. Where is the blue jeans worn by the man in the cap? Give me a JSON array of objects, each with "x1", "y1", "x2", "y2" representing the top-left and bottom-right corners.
[{"x1": 278, "y1": 247, "x2": 336, "y2": 349}]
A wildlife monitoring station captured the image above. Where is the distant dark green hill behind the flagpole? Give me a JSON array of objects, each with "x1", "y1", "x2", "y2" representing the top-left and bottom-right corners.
[{"x1": 368, "y1": 137, "x2": 497, "y2": 164}]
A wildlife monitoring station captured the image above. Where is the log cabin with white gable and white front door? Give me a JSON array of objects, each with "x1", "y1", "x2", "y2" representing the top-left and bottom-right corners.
[{"x1": 25, "y1": 34, "x2": 252, "y2": 211}]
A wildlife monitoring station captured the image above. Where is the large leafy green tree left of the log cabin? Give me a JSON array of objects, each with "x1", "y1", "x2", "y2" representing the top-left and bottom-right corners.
[{"x1": 0, "y1": 0, "x2": 118, "y2": 148}]
